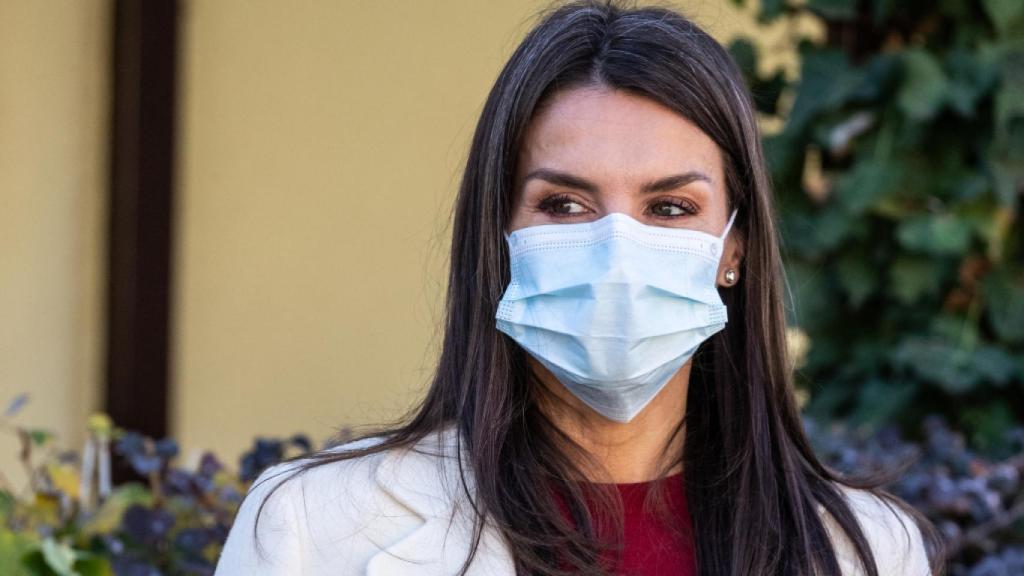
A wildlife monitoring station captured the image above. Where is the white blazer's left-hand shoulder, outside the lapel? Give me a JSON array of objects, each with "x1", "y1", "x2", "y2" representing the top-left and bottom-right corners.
[{"x1": 215, "y1": 437, "x2": 422, "y2": 576}]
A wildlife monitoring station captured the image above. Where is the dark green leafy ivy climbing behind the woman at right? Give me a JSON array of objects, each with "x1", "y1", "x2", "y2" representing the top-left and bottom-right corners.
[{"x1": 730, "y1": 0, "x2": 1024, "y2": 448}]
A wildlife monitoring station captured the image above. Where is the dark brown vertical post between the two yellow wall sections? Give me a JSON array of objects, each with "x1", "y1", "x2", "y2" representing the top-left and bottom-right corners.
[{"x1": 104, "y1": 0, "x2": 179, "y2": 448}]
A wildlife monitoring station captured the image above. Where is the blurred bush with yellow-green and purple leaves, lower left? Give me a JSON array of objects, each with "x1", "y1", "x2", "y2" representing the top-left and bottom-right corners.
[{"x1": 0, "y1": 396, "x2": 312, "y2": 576}]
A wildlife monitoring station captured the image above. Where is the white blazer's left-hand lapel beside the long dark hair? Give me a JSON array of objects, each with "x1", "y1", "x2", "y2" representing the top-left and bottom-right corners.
[{"x1": 367, "y1": 426, "x2": 515, "y2": 576}]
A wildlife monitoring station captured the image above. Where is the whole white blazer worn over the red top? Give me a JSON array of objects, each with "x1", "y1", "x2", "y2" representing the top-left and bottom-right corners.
[{"x1": 214, "y1": 426, "x2": 931, "y2": 576}]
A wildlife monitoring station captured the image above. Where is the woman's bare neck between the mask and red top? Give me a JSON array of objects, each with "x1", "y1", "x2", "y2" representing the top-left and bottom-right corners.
[{"x1": 530, "y1": 359, "x2": 690, "y2": 484}]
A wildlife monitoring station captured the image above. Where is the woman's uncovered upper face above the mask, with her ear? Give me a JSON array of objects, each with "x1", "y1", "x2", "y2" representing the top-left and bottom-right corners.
[{"x1": 508, "y1": 87, "x2": 742, "y2": 286}]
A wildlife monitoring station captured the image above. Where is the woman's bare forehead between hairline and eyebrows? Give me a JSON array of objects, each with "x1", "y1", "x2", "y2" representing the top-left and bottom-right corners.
[{"x1": 516, "y1": 87, "x2": 722, "y2": 183}]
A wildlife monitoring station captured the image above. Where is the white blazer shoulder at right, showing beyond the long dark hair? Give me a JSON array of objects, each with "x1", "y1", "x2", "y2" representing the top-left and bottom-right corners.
[{"x1": 823, "y1": 485, "x2": 932, "y2": 576}]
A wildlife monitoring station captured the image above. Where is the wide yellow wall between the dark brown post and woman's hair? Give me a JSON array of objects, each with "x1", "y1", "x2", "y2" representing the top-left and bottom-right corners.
[{"x1": 174, "y1": 0, "x2": 819, "y2": 458}]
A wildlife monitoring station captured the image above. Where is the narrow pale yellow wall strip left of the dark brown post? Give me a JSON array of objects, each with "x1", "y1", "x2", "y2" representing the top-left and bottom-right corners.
[{"x1": 0, "y1": 0, "x2": 110, "y2": 488}]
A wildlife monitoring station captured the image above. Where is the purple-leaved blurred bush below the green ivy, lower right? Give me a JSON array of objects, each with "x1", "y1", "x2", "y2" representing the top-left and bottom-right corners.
[{"x1": 804, "y1": 416, "x2": 1024, "y2": 576}]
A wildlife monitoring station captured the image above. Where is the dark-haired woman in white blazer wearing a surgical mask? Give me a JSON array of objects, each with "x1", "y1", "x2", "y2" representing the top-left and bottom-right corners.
[{"x1": 216, "y1": 2, "x2": 938, "y2": 576}]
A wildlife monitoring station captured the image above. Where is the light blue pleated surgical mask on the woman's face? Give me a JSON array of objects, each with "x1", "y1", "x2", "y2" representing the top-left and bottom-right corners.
[{"x1": 496, "y1": 210, "x2": 736, "y2": 422}]
